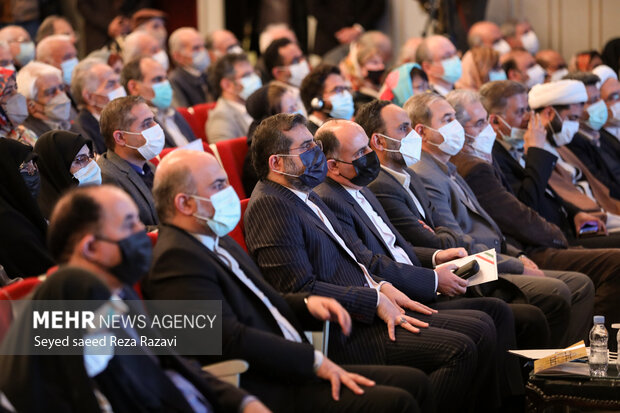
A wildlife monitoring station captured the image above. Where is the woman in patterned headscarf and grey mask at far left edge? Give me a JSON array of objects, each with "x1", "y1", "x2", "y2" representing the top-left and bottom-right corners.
[{"x1": 0, "y1": 67, "x2": 37, "y2": 145}]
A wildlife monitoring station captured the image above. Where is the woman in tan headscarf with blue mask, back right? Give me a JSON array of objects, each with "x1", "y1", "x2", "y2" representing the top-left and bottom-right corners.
[{"x1": 454, "y1": 46, "x2": 506, "y2": 90}]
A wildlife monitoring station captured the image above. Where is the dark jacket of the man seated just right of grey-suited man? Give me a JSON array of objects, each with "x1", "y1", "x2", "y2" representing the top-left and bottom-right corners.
[{"x1": 450, "y1": 151, "x2": 568, "y2": 251}]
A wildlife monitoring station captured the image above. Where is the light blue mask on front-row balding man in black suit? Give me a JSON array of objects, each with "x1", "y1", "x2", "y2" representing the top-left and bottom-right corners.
[{"x1": 190, "y1": 185, "x2": 241, "y2": 237}]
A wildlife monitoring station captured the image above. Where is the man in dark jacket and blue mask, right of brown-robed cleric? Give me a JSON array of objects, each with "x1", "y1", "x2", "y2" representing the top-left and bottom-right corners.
[{"x1": 564, "y1": 72, "x2": 620, "y2": 199}]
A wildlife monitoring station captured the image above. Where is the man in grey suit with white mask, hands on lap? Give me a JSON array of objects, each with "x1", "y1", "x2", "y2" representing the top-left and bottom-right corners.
[{"x1": 404, "y1": 93, "x2": 591, "y2": 346}]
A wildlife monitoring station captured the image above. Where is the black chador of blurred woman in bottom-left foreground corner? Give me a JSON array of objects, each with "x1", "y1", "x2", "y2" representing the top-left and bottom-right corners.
[{"x1": 0, "y1": 267, "x2": 110, "y2": 413}]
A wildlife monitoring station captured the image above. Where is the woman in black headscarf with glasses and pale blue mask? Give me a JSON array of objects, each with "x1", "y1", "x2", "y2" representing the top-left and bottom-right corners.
[{"x1": 34, "y1": 130, "x2": 101, "y2": 219}]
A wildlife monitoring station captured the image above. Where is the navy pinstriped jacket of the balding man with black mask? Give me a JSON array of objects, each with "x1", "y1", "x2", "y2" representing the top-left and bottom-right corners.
[{"x1": 315, "y1": 178, "x2": 437, "y2": 302}]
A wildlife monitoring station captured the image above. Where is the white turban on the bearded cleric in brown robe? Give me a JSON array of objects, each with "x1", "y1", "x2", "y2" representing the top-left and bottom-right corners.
[{"x1": 528, "y1": 80, "x2": 588, "y2": 109}]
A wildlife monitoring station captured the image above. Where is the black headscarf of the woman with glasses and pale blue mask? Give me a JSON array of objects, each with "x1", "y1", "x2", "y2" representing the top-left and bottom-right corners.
[{"x1": 34, "y1": 130, "x2": 93, "y2": 218}]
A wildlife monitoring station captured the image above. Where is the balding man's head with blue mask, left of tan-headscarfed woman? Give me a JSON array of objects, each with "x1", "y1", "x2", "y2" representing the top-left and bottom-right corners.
[{"x1": 416, "y1": 35, "x2": 462, "y2": 96}]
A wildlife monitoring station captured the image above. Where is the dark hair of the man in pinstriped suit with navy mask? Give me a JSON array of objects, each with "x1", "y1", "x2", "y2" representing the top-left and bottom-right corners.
[{"x1": 250, "y1": 113, "x2": 306, "y2": 180}]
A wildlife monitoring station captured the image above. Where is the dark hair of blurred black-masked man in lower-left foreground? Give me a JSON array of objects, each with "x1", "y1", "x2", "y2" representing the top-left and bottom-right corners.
[{"x1": 47, "y1": 186, "x2": 101, "y2": 264}]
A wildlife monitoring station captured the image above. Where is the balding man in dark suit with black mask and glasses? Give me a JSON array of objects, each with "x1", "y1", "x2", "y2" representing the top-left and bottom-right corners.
[{"x1": 315, "y1": 120, "x2": 522, "y2": 402}]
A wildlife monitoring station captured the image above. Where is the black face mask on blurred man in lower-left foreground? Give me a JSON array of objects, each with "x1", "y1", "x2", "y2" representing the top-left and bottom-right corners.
[{"x1": 98, "y1": 231, "x2": 153, "y2": 286}]
